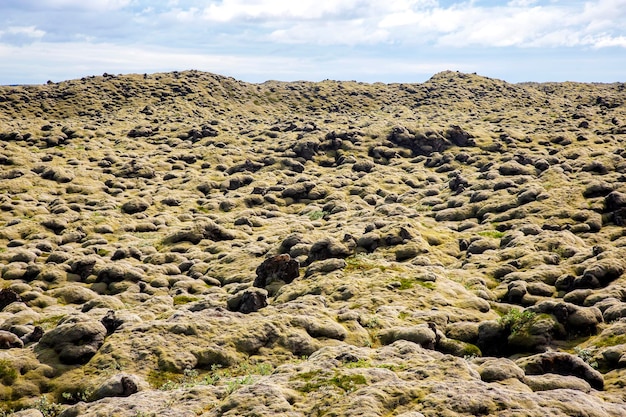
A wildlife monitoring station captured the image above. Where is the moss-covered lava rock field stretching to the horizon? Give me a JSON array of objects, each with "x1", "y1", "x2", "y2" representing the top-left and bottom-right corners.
[{"x1": 0, "y1": 71, "x2": 626, "y2": 417}]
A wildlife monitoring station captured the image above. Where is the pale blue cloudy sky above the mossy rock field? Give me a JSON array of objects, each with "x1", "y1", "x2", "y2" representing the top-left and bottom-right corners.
[{"x1": 0, "y1": 0, "x2": 626, "y2": 85}]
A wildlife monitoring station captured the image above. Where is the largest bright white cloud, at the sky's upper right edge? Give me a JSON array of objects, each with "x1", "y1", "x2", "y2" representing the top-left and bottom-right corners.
[{"x1": 370, "y1": 0, "x2": 626, "y2": 47}]
